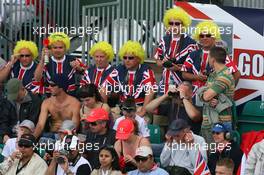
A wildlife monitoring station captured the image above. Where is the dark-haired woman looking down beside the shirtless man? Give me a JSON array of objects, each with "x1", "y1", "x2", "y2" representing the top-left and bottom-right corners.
[{"x1": 77, "y1": 84, "x2": 110, "y2": 134}]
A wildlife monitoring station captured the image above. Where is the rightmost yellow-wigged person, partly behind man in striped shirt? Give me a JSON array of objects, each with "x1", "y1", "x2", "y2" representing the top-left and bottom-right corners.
[{"x1": 182, "y1": 20, "x2": 240, "y2": 92}]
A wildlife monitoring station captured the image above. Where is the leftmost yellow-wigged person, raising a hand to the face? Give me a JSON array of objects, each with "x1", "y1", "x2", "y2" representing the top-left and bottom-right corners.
[{"x1": 0, "y1": 40, "x2": 38, "y2": 90}]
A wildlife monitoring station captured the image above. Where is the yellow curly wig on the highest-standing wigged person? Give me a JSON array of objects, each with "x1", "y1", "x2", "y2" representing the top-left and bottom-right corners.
[{"x1": 163, "y1": 7, "x2": 192, "y2": 28}]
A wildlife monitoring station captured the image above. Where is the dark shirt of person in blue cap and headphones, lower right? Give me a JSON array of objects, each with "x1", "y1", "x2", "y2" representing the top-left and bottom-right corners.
[{"x1": 208, "y1": 142, "x2": 243, "y2": 175}]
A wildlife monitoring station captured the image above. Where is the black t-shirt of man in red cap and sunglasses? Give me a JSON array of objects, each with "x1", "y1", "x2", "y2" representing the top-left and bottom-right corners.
[{"x1": 84, "y1": 129, "x2": 116, "y2": 169}]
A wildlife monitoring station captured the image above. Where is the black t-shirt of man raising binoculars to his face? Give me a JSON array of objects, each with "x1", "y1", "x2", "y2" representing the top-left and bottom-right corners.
[{"x1": 158, "y1": 99, "x2": 202, "y2": 135}]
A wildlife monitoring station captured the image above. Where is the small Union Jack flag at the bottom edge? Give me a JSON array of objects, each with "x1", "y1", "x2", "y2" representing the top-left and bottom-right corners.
[{"x1": 194, "y1": 151, "x2": 211, "y2": 175}]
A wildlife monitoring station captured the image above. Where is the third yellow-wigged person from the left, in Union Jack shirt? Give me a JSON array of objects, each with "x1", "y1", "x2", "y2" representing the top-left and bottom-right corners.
[{"x1": 81, "y1": 41, "x2": 115, "y2": 87}]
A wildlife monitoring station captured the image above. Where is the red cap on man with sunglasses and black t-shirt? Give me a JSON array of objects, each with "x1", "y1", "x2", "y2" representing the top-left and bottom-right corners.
[{"x1": 85, "y1": 108, "x2": 109, "y2": 122}]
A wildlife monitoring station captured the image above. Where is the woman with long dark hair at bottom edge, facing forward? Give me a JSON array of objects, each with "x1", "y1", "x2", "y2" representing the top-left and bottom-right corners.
[{"x1": 91, "y1": 146, "x2": 122, "y2": 175}]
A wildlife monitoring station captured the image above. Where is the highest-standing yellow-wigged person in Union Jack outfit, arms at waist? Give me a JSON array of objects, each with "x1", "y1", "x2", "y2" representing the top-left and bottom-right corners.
[{"x1": 154, "y1": 7, "x2": 198, "y2": 95}]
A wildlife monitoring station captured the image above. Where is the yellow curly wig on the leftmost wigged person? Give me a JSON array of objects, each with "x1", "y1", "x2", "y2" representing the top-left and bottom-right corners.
[{"x1": 13, "y1": 40, "x2": 38, "y2": 59}]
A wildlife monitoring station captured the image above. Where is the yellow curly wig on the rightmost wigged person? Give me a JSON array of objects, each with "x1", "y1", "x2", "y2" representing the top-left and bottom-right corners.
[{"x1": 193, "y1": 21, "x2": 221, "y2": 41}]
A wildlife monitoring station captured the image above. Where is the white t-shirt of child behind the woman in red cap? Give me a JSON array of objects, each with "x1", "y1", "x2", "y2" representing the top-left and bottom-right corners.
[{"x1": 113, "y1": 115, "x2": 150, "y2": 137}]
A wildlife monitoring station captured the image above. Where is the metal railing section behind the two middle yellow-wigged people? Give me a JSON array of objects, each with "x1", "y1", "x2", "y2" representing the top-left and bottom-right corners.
[{"x1": 82, "y1": 0, "x2": 174, "y2": 63}]
